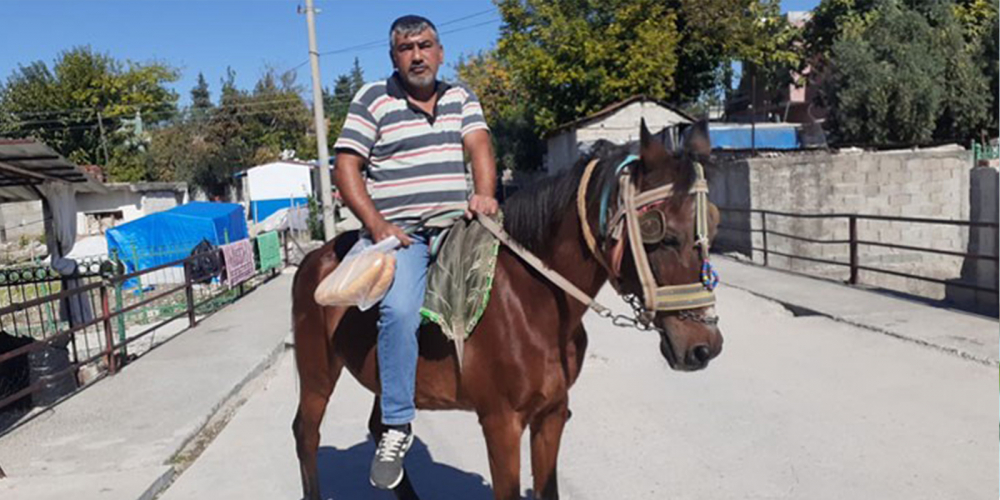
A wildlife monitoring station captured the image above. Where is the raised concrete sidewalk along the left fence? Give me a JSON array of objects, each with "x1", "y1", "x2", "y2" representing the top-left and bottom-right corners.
[{"x1": 0, "y1": 269, "x2": 294, "y2": 500}]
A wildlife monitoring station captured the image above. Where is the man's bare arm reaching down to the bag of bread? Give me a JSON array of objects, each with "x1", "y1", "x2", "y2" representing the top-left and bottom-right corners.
[{"x1": 333, "y1": 150, "x2": 411, "y2": 246}]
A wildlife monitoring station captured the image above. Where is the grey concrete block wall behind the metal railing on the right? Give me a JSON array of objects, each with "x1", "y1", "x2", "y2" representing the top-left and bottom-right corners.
[{"x1": 710, "y1": 147, "x2": 984, "y2": 299}]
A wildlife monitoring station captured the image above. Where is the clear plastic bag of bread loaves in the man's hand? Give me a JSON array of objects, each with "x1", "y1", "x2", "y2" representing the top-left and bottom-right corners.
[{"x1": 313, "y1": 236, "x2": 399, "y2": 311}]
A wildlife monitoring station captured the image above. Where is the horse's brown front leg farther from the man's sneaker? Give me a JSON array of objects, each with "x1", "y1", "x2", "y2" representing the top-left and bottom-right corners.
[{"x1": 531, "y1": 400, "x2": 569, "y2": 500}]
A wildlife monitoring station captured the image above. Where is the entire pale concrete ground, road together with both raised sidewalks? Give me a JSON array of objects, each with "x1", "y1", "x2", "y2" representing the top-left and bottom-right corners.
[{"x1": 0, "y1": 259, "x2": 998, "y2": 500}]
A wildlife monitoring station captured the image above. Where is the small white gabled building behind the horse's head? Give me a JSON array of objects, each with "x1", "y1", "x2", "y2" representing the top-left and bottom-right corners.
[{"x1": 545, "y1": 96, "x2": 694, "y2": 174}]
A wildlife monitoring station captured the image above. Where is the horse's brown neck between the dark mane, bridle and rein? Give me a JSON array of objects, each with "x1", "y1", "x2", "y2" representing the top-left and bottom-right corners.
[{"x1": 539, "y1": 200, "x2": 608, "y2": 297}]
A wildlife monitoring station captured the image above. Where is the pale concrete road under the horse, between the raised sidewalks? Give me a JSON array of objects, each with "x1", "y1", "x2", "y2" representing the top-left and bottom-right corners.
[{"x1": 161, "y1": 288, "x2": 998, "y2": 500}]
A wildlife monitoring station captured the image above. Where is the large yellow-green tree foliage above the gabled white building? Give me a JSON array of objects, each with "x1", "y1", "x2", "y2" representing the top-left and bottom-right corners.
[{"x1": 492, "y1": 0, "x2": 802, "y2": 133}]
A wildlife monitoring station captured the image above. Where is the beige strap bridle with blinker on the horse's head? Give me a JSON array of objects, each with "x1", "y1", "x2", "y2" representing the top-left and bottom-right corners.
[{"x1": 577, "y1": 155, "x2": 719, "y2": 324}]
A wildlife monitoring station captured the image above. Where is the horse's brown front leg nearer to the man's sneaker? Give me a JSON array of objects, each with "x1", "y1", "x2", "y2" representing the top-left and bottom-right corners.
[{"x1": 479, "y1": 412, "x2": 524, "y2": 500}]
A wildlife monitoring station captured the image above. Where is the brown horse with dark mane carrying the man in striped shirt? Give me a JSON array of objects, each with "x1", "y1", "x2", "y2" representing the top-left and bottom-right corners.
[{"x1": 292, "y1": 124, "x2": 722, "y2": 500}]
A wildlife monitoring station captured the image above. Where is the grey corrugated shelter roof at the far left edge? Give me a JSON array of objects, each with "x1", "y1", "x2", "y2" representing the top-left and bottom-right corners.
[{"x1": 0, "y1": 138, "x2": 102, "y2": 200}]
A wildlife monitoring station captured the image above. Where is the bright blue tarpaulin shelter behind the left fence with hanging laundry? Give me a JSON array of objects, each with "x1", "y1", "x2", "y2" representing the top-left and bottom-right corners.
[{"x1": 105, "y1": 201, "x2": 248, "y2": 278}]
